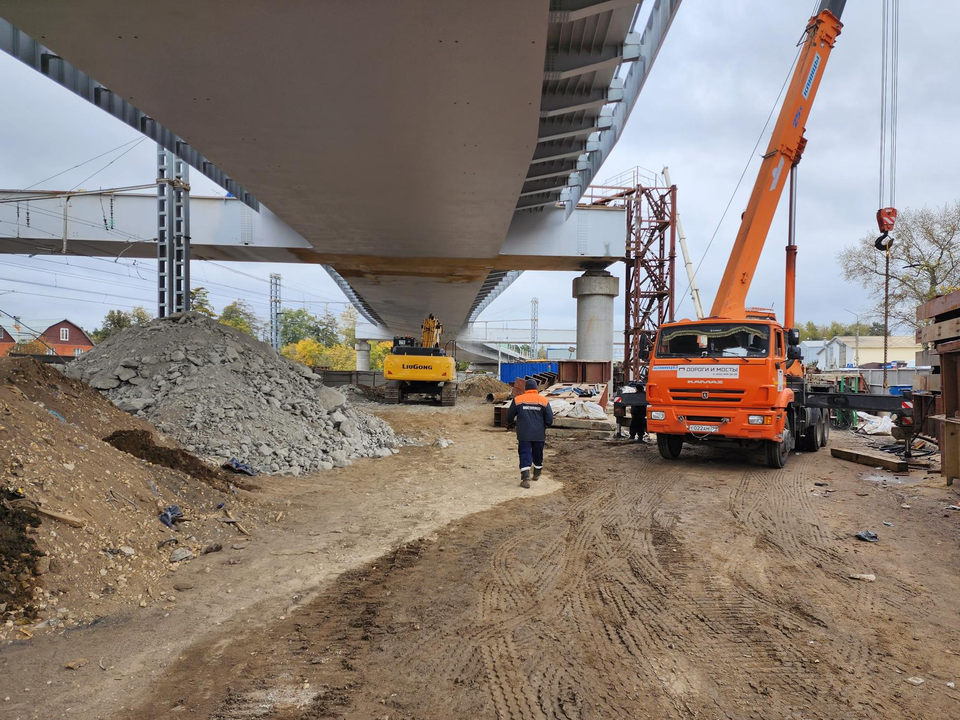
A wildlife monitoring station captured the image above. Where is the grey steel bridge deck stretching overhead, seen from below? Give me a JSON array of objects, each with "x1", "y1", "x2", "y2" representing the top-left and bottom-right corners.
[{"x1": 0, "y1": 0, "x2": 679, "y2": 332}]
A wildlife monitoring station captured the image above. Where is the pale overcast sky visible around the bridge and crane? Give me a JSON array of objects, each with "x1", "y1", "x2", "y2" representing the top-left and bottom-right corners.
[{"x1": 0, "y1": 0, "x2": 960, "y2": 344}]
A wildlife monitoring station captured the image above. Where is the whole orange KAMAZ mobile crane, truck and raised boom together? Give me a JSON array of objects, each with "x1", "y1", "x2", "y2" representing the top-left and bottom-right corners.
[{"x1": 646, "y1": 0, "x2": 846, "y2": 468}]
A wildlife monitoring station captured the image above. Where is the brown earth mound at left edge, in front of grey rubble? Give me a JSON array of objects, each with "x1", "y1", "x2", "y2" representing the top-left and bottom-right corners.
[{"x1": 0, "y1": 358, "x2": 265, "y2": 640}]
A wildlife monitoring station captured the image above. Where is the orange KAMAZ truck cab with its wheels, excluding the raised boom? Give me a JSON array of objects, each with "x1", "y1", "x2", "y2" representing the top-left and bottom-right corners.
[{"x1": 646, "y1": 312, "x2": 826, "y2": 467}]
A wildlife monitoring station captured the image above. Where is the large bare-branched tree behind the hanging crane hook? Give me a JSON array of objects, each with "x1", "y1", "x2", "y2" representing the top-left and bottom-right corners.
[{"x1": 838, "y1": 200, "x2": 960, "y2": 332}]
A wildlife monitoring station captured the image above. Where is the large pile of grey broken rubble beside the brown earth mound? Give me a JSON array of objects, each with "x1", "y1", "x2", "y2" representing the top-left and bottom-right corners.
[{"x1": 66, "y1": 313, "x2": 400, "y2": 475}]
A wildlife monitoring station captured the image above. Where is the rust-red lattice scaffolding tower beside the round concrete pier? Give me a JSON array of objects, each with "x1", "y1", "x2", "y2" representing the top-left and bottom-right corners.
[{"x1": 582, "y1": 168, "x2": 677, "y2": 382}]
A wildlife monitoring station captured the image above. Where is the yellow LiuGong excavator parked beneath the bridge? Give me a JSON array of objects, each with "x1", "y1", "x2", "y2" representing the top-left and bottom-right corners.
[{"x1": 383, "y1": 314, "x2": 457, "y2": 407}]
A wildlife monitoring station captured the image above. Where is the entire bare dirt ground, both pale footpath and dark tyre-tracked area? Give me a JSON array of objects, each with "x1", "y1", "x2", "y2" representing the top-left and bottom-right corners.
[{"x1": 0, "y1": 396, "x2": 960, "y2": 720}]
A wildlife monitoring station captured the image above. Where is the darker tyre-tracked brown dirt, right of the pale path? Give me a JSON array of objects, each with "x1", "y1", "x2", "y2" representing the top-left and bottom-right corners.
[{"x1": 110, "y1": 430, "x2": 960, "y2": 720}]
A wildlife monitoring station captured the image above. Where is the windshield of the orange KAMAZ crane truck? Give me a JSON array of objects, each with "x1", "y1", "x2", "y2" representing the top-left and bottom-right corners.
[{"x1": 657, "y1": 323, "x2": 770, "y2": 358}]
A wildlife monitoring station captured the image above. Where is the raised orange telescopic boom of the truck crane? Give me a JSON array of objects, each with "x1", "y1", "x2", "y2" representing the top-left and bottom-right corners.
[{"x1": 710, "y1": 0, "x2": 846, "y2": 318}]
